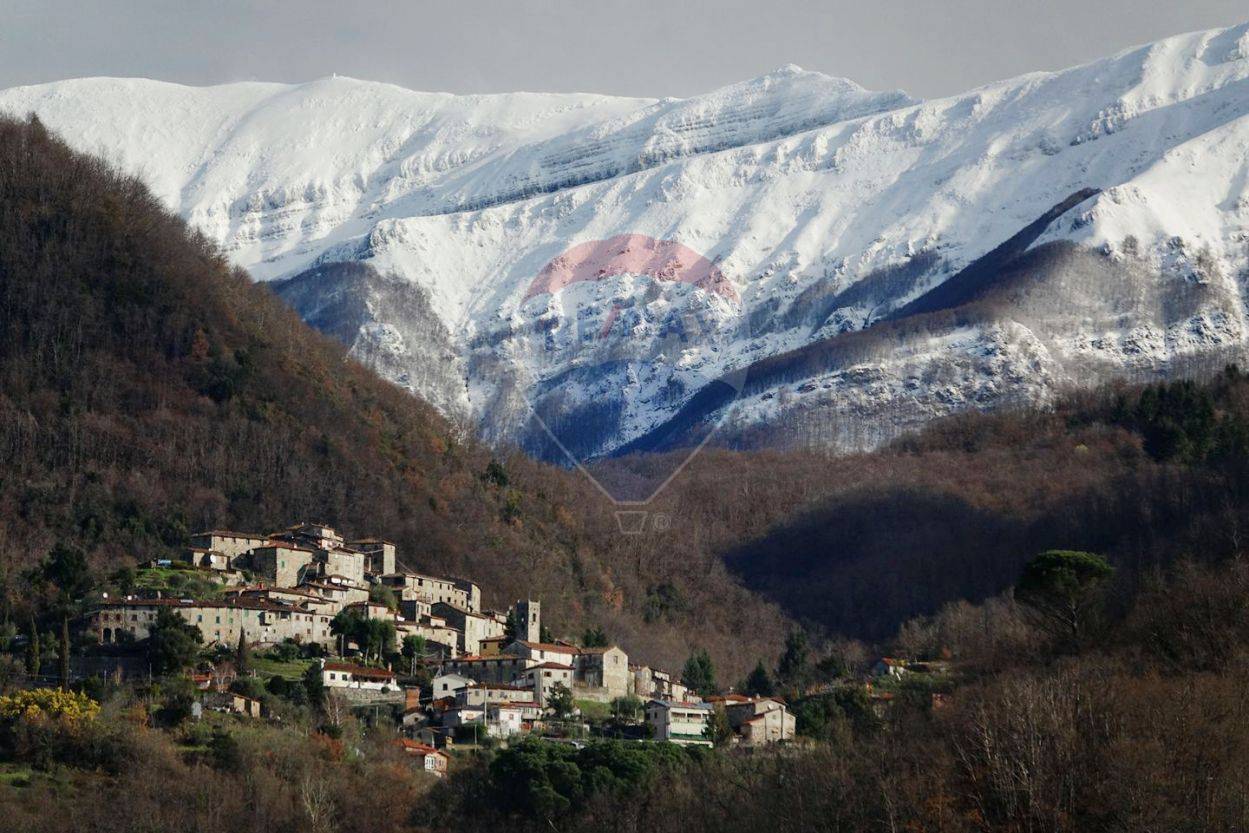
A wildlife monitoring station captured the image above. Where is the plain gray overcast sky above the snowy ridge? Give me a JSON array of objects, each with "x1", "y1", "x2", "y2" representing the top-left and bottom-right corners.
[{"x1": 0, "y1": 0, "x2": 1249, "y2": 97}]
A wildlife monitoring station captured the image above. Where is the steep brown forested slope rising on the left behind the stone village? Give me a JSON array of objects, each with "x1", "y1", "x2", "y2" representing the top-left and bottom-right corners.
[{"x1": 0, "y1": 120, "x2": 783, "y2": 673}]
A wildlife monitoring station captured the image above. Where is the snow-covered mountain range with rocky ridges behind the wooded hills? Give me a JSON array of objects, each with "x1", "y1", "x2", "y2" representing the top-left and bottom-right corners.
[{"x1": 7, "y1": 25, "x2": 1249, "y2": 457}]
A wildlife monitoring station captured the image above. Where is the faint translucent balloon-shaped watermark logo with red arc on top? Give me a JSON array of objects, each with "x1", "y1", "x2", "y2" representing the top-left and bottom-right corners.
[{"x1": 522, "y1": 234, "x2": 748, "y2": 535}]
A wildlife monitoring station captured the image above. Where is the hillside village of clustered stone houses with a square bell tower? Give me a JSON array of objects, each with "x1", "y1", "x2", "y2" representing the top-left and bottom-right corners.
[{"x1": 84, "y1": 523, "x2": 794, "y2": 754}]
